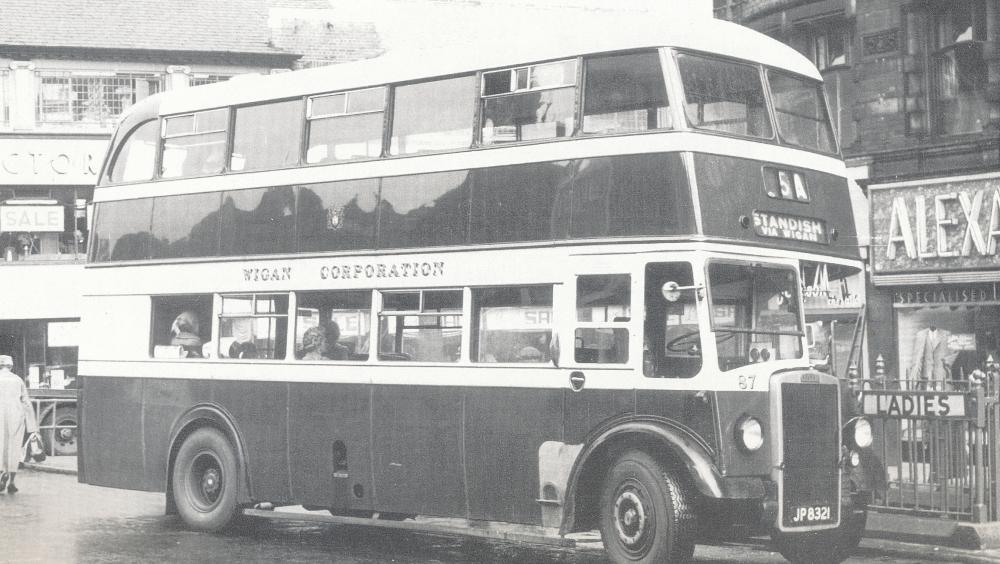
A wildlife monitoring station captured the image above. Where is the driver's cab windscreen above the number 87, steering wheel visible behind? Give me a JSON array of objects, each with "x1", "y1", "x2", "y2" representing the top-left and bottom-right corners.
[{"x1": 708, "y1": 262, "x2": 803, "y2": 370}]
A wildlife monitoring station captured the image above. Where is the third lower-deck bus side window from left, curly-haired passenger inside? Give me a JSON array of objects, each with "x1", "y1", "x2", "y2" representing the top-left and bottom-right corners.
[{"x1": 295, "y1": 291, "x2": 372, "y2": 361}]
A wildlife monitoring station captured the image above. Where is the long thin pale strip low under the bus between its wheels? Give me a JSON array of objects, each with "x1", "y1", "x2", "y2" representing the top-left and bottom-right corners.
[{"x1": 243, "y1": 508, "x2": 576, "y2": 548}]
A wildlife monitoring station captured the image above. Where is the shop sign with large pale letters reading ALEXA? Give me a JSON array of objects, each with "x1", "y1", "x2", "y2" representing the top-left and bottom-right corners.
[{"x1": 871, "y1": 176, "x2": 1000, "y2": 272}]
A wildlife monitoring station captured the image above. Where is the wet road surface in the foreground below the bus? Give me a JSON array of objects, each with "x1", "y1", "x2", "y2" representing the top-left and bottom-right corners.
[{"x1": 0, "y1": 471, "x2": 984, "y2": 564}]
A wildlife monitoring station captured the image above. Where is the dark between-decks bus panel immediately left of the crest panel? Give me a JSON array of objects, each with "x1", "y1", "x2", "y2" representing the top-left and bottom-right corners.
[{"x1": 220, "y1": 186, "x2": 295, "y2": 256}]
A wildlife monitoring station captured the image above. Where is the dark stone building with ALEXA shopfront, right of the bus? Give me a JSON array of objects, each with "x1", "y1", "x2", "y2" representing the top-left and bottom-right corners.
[{"x1": 715, "y1": 0, "x2": 1000, "y2": 379}]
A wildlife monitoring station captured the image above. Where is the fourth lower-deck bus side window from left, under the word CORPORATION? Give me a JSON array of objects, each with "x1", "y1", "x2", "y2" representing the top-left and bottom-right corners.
[{"x1": 378, "y1": 290, "x2": 463, "y2": 362}]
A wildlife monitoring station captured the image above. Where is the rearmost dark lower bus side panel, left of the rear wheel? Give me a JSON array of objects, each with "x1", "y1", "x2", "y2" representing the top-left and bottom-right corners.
[{"x1": 80, "y1": 376, "x2": 152, "y2": 491}]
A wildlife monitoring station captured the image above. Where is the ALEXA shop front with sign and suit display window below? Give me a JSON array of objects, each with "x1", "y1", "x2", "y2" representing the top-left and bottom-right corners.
[{"x1": 869, "y1": 173, "x2": 1000, "y2": 388}]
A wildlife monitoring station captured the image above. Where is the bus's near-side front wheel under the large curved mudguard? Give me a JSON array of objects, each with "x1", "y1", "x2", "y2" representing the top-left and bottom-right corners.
[{"x1": 600, "y1": 450, "x2": 695, "y2": 564}]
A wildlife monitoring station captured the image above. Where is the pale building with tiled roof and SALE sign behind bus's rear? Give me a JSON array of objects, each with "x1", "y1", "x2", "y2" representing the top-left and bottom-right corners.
[{"x1": 0, "y1": 0, "x2": 299, "y2": 388}]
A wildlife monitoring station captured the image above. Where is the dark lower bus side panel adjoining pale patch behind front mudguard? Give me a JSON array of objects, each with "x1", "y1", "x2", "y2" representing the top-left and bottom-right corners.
[{"x1": 465, "y1": 388, "x2": 563, "y2": 524}]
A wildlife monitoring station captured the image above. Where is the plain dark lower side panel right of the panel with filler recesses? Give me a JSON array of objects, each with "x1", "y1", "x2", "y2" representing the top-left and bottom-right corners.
[{"x1": 372, "y1": 385, "x2": 466, "y2": 516}]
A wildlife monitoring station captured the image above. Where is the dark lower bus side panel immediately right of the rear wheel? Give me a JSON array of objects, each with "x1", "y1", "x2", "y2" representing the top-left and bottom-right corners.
[{"x1": 212, "y1": 378, "x2": 292, "y2": 502}]
